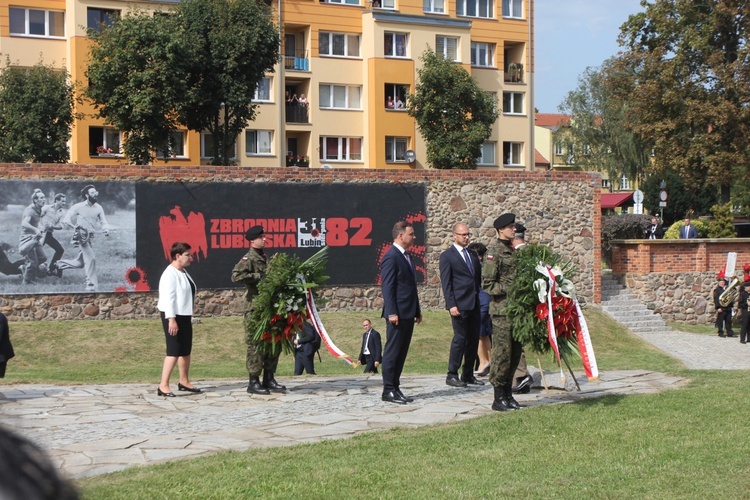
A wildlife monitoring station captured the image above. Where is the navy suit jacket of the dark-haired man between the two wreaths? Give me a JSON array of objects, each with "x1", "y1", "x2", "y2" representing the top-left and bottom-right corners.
[{"x1": 380, "y1": 245, "x2": 422, "y2": 319}]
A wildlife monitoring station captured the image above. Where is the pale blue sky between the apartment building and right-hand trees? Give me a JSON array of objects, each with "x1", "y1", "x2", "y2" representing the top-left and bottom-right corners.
[{"x1": 534, "y1": 0, "x2": 643, "y2": 113}]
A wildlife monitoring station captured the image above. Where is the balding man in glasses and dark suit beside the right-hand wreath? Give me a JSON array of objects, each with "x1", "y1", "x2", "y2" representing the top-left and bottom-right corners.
[{"x1": 440, "y1": 222, "x2": 484, "y2": 387}]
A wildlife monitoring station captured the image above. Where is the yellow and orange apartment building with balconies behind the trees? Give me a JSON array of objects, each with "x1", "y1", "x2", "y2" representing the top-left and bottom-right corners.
[{"x1": 0, "y1": 0, "x2": 534, "y2": 170}]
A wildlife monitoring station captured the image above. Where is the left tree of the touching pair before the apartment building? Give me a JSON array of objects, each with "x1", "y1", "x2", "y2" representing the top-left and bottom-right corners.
[{"x1": 85, "y1": 12, "x2": 187, "y2": 165}]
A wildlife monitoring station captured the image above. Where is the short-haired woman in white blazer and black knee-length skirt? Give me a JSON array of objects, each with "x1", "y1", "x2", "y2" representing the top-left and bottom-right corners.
[{"x1": 156, "y1": 241, "x2": 201, "y2": 398}]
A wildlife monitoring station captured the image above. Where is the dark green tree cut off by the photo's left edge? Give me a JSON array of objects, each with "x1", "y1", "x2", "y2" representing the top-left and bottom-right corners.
[{"x1": 0, "y1": 59, "x2": 74, "y2": 163}]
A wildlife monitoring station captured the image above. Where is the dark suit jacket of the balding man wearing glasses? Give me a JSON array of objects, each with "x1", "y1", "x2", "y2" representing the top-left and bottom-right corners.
[{"x1": 440, "y1": 245, "x2": 482, "y2": 312}]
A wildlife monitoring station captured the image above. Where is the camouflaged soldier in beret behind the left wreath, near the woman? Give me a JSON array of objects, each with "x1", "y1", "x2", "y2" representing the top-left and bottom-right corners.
[{"x1": 232, "y1": 226, "x2": 286, "y2": 394}]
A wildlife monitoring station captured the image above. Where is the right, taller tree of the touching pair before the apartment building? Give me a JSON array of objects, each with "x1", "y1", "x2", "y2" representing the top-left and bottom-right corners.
[{"x1": 176, "y1": 0, "x2": 280, "y2": 165}]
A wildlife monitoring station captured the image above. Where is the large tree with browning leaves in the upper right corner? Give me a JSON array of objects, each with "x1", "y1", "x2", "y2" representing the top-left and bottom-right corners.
[{"x1": 610, "y1": 0, "x2": 750, "y2": 202}]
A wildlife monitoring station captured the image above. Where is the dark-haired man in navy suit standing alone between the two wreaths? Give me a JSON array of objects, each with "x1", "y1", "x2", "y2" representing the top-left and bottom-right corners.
[{"x1": 380, "y1": 221, "x2": 422, "y2": 404}]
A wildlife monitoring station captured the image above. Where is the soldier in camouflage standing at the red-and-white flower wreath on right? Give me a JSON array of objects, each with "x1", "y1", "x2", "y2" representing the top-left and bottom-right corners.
[{"x1": 482, "y1": 214, "x2": 522, "y2": 411}]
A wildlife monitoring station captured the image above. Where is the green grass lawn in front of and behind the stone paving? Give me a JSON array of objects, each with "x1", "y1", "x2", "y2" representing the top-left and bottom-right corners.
[{"x1": 3, "y1": 309, "x2": 750, "y2": 499}]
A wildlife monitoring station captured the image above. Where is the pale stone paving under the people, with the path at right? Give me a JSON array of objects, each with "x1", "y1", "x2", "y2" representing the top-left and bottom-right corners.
[{"x1": 0, "y1": 324, "x2": 750, "y2": 477}]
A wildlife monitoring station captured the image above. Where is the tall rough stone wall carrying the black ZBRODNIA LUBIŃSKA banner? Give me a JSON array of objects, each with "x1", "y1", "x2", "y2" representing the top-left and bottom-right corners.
[{"x1": 0, "y1": 164, "x2": 601, "y2": 320}]
